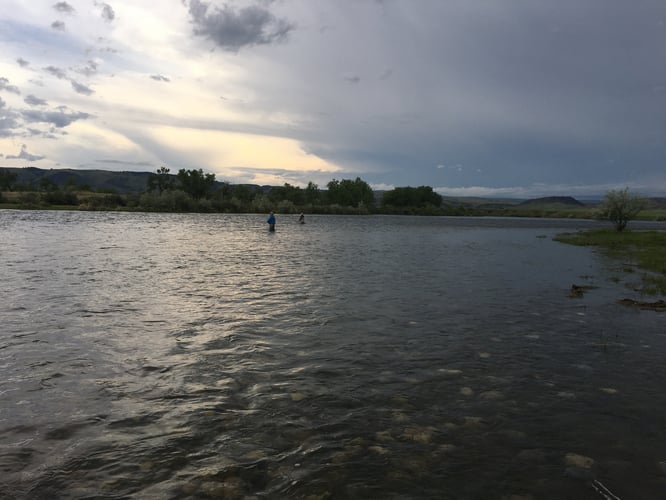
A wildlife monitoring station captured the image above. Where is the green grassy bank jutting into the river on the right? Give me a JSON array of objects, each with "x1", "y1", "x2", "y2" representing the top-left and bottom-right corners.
[{"x1": 555, "y1": 229, "x2": 666, "y2": 295}]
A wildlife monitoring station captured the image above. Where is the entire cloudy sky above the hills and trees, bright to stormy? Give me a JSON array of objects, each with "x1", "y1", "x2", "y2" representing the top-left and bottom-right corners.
[{"x1": 0, "y1": 0, "x2": 666, "y2": 197}]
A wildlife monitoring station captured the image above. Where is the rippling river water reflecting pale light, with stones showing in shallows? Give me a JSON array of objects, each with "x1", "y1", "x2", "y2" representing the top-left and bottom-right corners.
[{"x1": 0, "y1": 210, "x2": 666, "y2": 500}]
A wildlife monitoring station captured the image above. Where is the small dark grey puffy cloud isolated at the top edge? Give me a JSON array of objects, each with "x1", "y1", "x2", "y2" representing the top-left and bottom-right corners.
[{"x1": 189, "y1": 0, "x2": 294, "y2": 52}]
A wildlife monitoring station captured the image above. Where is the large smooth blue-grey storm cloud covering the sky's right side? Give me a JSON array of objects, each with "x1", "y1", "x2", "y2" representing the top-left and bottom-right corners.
[{"x1": 286, "y1": 0, "x2": 666, "y2": 193}]
